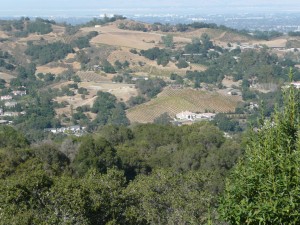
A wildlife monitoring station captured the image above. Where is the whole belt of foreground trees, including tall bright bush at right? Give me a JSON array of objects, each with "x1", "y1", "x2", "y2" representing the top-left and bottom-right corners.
[{"x1": 0, "y1": 79, "x2": 300, "y2": 224}]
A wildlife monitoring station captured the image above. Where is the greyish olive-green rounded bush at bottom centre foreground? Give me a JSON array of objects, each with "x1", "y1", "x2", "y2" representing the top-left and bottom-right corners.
[{"x1": 128, "y1": 169, "x2": 212, "y2": 224}]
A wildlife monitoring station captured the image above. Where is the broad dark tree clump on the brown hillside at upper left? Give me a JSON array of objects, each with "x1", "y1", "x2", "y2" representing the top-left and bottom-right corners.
[{"x1": 25, "y1": 42, "x2": 73, "y2": 64}]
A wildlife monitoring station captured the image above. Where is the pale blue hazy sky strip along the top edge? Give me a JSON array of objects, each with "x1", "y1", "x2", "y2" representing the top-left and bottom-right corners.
[{"x1": 0, "y1": 0, "x2": 300, "y2": 16}]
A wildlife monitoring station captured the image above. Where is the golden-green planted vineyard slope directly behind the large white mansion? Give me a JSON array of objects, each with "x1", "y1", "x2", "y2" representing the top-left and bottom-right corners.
[{"x1": 127, "y1": 88, "x2": 241, "y2": 123}]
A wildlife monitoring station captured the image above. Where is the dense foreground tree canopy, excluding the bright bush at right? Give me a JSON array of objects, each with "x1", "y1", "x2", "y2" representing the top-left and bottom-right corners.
[{"x1": 0, "y1": 119, "x2": 244, "y2": 224}]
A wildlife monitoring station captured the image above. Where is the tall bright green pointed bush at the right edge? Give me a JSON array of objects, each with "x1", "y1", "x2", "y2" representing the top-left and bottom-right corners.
[{"x1": 220, "y1": 73, "x2": 300, "y2": 224}]
